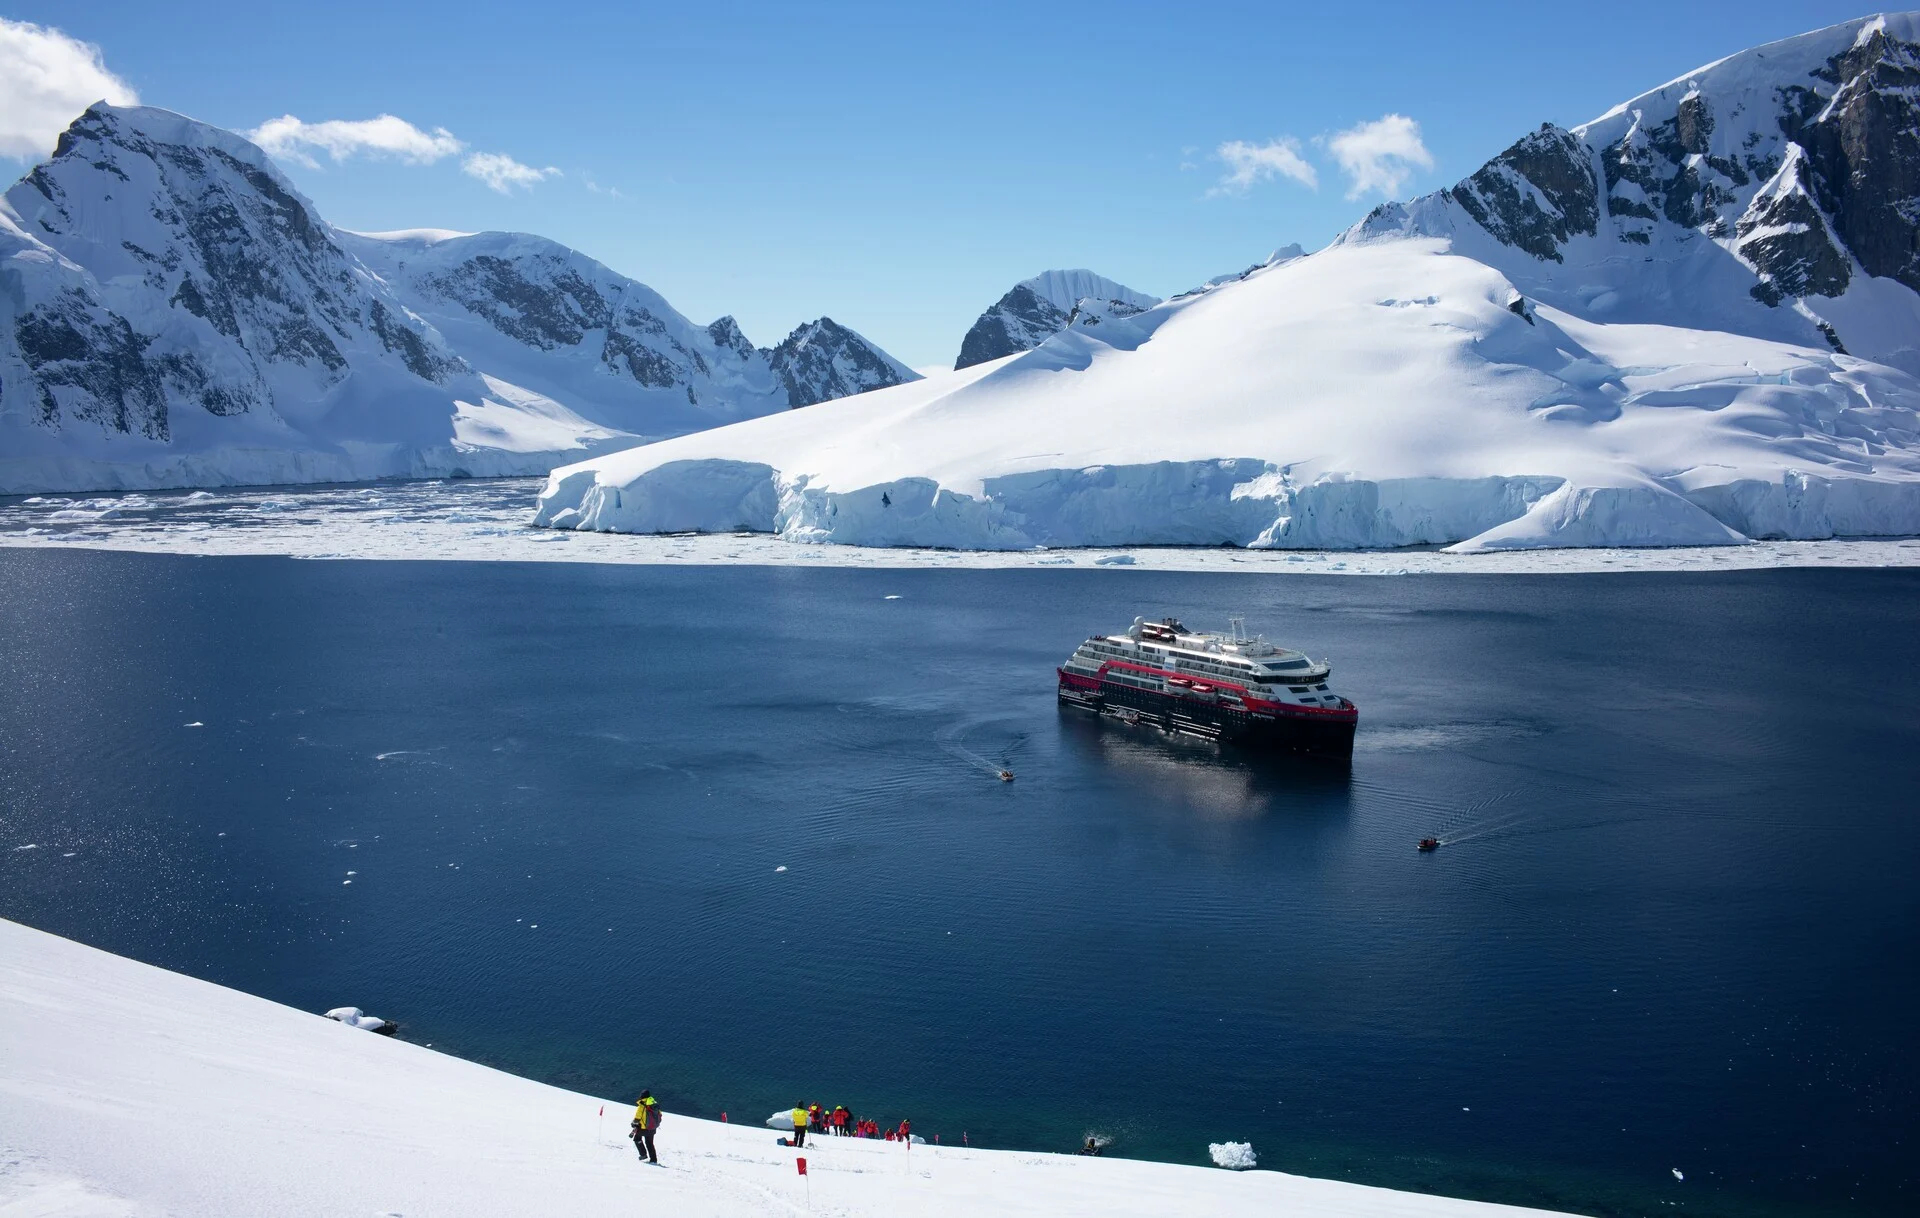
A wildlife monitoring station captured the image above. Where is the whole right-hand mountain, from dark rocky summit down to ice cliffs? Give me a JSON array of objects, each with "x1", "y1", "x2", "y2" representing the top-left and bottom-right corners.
[{"x1": 536, "y1": 15, "x2": 1920, "y2": 549}]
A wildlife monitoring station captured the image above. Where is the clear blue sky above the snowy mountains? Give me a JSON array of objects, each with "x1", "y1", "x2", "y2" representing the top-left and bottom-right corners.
[{"x1": 0, "y1": 0, "x2": 1889, "y2": 365}]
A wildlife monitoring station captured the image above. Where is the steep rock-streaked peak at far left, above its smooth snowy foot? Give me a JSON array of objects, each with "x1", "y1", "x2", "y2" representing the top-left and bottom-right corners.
[{"x1": 0, "y1": 104, "x2": 465, "y2": 440}]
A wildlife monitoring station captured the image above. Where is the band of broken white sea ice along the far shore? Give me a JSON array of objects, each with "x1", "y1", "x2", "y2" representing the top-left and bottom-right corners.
[{"x1": 0, "y1": 478, "x2": 1920, "y2": 574}]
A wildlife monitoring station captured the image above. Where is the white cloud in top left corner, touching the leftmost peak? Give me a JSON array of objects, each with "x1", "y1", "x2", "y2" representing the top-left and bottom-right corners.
[{"x1": 0, "y1": 17, "x2": 140, "y2": 159}]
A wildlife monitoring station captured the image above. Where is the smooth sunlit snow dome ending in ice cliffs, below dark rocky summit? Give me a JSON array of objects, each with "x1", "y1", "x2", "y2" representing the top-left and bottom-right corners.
[{"x1": 536, "y1": 238, "x2": 1920, "y2": 549}]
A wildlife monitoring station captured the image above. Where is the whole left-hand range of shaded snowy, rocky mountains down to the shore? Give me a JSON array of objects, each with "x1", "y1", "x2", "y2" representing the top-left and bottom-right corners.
[{"x1": 0, "y1": 104, "x2": 914, "y2": 492}]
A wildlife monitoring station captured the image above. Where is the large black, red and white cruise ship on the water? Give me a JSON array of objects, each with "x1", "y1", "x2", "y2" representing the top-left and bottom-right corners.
[{"x1": 1058, "y1": 617, "x2": 1359, "y2": 759}]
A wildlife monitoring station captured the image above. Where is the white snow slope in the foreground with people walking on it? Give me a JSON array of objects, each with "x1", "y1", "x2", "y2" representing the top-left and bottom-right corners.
[{"x1": 0, "y1": 922, "x2": 1574, "y2": 1218}]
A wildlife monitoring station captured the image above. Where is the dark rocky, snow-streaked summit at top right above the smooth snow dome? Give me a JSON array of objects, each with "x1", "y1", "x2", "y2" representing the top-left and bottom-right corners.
[{"x1": 1342, "y1": 13, "x2": 1920, "y2": 373}]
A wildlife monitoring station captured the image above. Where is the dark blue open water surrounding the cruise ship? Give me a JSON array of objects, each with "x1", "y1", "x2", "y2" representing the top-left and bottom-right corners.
[{"x1": 0, "y1": 551, "x2": 1920, "y2": 1214}]
